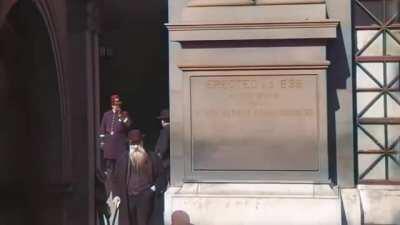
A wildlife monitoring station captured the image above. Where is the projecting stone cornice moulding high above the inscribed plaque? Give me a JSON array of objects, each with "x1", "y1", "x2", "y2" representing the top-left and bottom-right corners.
[{"x1": 166, "y1": 20, "x2": 339, "y2": 42}]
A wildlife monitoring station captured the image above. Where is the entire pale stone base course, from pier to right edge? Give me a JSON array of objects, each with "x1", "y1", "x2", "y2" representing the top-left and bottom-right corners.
[{"x1": 165, "y1": 183, "x2": 400, "y2": 225}]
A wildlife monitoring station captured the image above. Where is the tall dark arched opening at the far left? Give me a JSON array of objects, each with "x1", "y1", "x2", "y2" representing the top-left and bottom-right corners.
[{"x1": 0, "y1": 1, "x2": 63, "y2": 225}]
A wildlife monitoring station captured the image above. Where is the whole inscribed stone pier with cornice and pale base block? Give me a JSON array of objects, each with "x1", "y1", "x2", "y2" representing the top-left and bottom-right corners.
[{"x1": 165, "y1": 0, "x2": 341, "y2": 225}]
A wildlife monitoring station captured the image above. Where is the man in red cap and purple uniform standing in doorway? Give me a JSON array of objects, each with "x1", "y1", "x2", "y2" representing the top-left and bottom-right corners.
[{"x1": 100, "y1": 95, "x2": 131, "y2": 174}]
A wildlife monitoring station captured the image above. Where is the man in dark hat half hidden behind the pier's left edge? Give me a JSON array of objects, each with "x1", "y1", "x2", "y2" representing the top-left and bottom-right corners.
[{"x1": 151, "y1": 109, "x2": 170, "y2": 225}]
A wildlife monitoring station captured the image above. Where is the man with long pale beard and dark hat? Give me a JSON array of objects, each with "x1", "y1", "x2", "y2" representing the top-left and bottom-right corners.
[{"x1": 112, "y1": 130, "x2": 162, "y2": 225}]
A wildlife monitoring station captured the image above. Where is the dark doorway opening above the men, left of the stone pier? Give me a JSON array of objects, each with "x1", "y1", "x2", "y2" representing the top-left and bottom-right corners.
[{"x1": 100, "y1": 0, "x2": 169, "y2": 151}]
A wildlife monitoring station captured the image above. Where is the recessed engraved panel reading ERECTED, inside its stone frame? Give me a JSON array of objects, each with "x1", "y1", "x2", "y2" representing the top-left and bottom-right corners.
[{"x1": 190, "y1": 75, "x2": 320, "y2": 171}]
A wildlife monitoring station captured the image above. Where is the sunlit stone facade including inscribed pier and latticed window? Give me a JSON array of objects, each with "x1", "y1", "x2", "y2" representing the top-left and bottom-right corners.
[{"x1": 165, "y1": 0, "x2": 400, "y2": 225}]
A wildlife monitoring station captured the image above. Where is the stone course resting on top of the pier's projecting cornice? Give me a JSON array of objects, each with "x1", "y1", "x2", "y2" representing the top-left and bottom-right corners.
[{"x1": 180, "y1": 3, "x2": 327, "y2": 24}]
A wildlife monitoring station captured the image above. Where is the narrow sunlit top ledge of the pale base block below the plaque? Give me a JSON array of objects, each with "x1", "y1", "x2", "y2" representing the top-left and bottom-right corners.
[{"x1": 171, "y1": 183, "x2": 338, "y2": 198}]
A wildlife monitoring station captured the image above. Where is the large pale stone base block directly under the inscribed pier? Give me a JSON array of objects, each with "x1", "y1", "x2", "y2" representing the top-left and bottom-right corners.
[{"x1": 164, "y1": 183, "x2": 341, "y2": 225}]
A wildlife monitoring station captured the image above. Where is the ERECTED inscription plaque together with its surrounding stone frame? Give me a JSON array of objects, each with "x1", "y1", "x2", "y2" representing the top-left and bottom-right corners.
[{"x1": 182, "y1": 65, "x2": 329, "y2": 183}]
